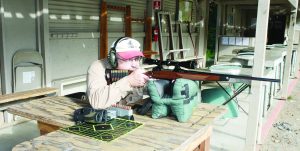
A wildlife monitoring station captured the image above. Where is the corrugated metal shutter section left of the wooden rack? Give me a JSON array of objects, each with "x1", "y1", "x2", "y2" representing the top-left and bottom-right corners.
[{"x1": 49, "y1": 0, "x2": 99, "y2": 32}]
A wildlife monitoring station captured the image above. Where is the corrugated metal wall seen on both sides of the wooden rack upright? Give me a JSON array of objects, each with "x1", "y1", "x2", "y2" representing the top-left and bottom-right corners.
[{"x1": 49, "y1": 0, "x2": 147, "y2": 32}]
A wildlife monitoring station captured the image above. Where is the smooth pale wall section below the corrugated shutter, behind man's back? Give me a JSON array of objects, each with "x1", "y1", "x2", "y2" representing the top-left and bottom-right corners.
[{"x1": 49, "y1": 38, "x2": 98, "y2": 81}]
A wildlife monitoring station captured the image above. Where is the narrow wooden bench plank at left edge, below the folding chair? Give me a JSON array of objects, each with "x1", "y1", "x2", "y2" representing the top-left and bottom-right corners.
[{"x1": 0, "y1": 88, "x2": 57, "y2": 127}]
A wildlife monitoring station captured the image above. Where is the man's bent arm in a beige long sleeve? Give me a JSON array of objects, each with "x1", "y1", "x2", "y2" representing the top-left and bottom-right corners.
[{"x1": 87, "y1": 61, "x2": 132, "y2": 109}]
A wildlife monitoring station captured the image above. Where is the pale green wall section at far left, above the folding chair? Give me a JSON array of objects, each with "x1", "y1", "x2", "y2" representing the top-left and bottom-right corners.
[{"x1": 1, "y1": 0, "x2": 37, "y2": 93}]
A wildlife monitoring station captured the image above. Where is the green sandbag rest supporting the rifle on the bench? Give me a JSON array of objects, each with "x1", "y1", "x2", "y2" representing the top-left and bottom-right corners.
[{"x1": 147, "y1": 79, "x2": 199, "y2": 122}]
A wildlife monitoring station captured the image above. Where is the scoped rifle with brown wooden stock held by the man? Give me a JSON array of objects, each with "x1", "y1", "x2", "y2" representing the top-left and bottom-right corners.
[{"x1": 106, "y1": 59, "x2": 280, "y2": 84}]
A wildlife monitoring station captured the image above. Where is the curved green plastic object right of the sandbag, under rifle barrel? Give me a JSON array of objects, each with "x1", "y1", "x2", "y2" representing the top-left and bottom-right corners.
[{"x1": 201, "y1": 87, "x2": 239, "y2": 118}]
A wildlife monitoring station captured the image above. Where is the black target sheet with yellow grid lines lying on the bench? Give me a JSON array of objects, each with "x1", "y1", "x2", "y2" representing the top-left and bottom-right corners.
[{"x1": 61, "y1": 118, "x2": 143, "y2": 142}]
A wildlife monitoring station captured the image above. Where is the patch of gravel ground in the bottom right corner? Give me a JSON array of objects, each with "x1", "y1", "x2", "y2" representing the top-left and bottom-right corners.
[{"x1": 259, "y1": 81, "x2": 300, "y2": 151}]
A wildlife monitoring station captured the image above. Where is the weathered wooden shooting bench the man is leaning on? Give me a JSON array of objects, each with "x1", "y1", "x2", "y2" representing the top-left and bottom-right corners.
[{"x1": 8, "y1": 96, "x2": 225, "y2": 151}]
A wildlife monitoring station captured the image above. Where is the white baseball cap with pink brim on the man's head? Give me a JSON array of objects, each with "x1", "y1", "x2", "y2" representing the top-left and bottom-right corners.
[{"x1": 112, "y1": 37, "x2": 144, "y2": 60}]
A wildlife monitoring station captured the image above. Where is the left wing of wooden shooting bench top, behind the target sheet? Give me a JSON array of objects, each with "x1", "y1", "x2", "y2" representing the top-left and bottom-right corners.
[{"x1": 7, "y1": 96, "x2": 89, "y2": 127}]
